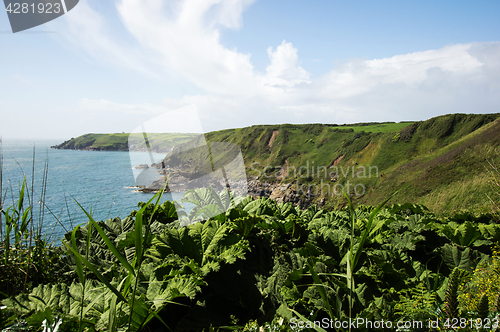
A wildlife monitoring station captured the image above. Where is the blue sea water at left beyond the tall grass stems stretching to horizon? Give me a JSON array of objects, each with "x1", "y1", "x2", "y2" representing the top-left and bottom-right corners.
[{"x1": 2, "y1": 139, "x2": 186, "y2": 244}]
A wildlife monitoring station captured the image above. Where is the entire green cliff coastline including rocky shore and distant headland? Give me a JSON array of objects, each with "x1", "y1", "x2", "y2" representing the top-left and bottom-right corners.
[{"x1": 54, "y1": 114, "x2": 500, "y2": 213}]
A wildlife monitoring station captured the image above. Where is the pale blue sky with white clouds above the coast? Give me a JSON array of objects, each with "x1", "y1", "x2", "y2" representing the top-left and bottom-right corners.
[{"x1": 0, "y1": 0, "x2": 500, "y2": 139}]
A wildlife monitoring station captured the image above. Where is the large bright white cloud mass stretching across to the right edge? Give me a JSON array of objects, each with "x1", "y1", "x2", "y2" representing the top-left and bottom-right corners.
[{"x1": 56, "y1": 0, "x2": 500, "y2": 131}]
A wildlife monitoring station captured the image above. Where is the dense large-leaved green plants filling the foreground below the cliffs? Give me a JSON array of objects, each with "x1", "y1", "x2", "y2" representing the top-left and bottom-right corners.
[{"x1": 0, "y1": 188, "x2": 500, "y2": 331}]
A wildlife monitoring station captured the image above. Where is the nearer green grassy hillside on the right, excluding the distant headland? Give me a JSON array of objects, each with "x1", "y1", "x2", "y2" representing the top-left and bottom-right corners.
[{"x1": 202, "y1": 114, "x2": 500, "y2": 214}]
